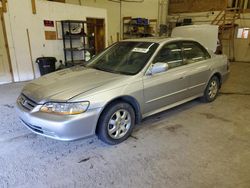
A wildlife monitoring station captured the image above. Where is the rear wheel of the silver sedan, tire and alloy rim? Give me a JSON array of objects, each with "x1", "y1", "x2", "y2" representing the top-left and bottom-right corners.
[{"x1": 202, "y1": 76, "x2": 220, "y2": 102}]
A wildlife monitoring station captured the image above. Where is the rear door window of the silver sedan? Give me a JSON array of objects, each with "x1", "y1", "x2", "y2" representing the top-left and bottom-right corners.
[{"x1": 182, "y1": 42, "x2": 210, "y2": 64}]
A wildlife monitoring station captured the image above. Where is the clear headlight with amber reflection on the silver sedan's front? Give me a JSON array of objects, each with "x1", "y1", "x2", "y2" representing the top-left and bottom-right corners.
[{"x1": 40, "y1": 102, "x2": 89, "y2": 115}]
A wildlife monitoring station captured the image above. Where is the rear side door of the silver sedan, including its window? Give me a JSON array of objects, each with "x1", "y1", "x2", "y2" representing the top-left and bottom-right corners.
[{"x1": 182, "y1": 41, "x2": 211, "y2": 97}]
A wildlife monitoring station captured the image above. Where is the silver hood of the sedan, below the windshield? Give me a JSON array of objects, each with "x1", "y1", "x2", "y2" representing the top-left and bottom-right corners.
[{"x1": 22, "y1": 66, "x2": 128, "y2": 103}]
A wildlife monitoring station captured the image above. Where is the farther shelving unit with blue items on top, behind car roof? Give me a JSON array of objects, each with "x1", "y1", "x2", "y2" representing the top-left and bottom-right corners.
[{"x1": 123, "y1": 17, "x2": 157, "y2": 39}]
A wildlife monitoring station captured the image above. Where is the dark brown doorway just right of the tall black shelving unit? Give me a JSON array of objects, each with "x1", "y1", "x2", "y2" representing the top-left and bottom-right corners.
[{"x1": 87, "y1": 18, "x2": 105, "y2": 54}]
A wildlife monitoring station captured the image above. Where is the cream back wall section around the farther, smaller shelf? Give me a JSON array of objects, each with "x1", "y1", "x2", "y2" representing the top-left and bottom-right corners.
[{"x1": 66, "y1": 0, "x2": 158, "y2": 44}]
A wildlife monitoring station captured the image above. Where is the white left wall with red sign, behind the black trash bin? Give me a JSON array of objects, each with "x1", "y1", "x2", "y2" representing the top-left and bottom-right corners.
[{"x1": 4, "y1": 0, "x2": 108, "y2": 81}]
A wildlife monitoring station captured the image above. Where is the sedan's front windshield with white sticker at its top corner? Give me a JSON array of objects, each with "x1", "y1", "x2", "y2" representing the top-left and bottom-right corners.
[{"x1": 86, "y1": 41, "x2": 159, "y2": 75}]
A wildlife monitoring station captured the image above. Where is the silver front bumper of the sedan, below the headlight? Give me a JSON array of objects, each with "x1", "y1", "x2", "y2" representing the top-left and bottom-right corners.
[{"x1": 16, "y1": 98, "x2": 101, "y2": 141}]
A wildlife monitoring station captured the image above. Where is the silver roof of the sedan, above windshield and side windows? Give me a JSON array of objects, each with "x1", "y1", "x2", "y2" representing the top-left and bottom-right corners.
[{"x1": 123, "y1": 37, "x2": 195, "y2": 44}]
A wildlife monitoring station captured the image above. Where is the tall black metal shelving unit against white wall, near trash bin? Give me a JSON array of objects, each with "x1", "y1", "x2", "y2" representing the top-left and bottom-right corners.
[{"x1": 61, "y1": 20, "x2": 95, "y2": 67}]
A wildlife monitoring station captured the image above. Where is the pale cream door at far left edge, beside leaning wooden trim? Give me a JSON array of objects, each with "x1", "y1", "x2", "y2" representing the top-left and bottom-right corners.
[{"x1": 0, "y1": 8, "x2": 12, "y2": 84}]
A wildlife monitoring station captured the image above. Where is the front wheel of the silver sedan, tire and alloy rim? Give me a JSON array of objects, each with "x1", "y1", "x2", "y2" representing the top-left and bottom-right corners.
[{"x1": 96, "y1": 102, "x2": 135, "y2": 145}]
